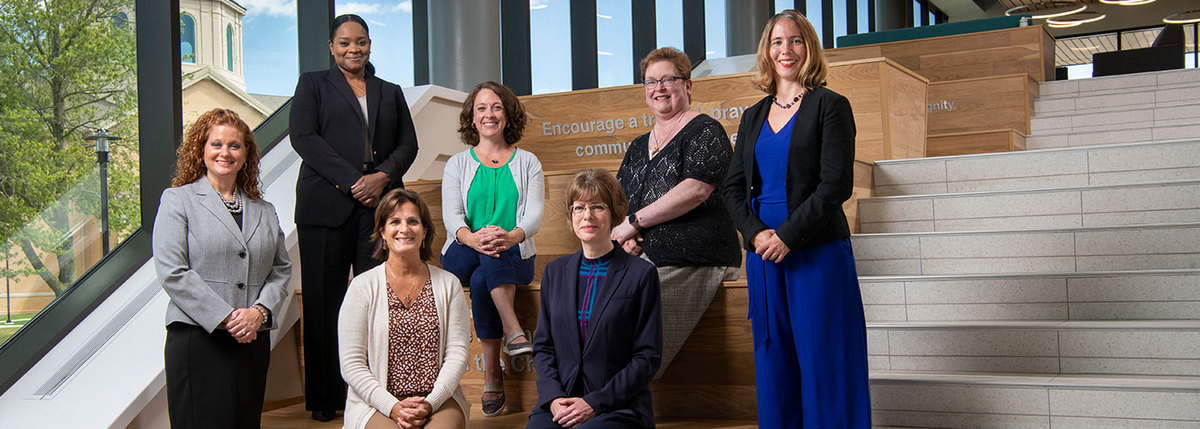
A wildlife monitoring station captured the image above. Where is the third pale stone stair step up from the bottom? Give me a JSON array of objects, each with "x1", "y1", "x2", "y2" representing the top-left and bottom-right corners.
[{"x1": 859, "y1": 270, "x2": 1200, "y2": 324}]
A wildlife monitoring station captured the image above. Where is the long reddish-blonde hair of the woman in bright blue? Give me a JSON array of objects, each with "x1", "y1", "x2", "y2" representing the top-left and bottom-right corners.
[{"x1": 751, "y1": 10, "x2": 829, "y2": 93}]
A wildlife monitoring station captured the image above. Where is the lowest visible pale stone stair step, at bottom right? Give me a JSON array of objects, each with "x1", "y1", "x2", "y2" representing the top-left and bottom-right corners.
[{"x1": 871, "y1": 371, "x2": 1200, "y2": 429}]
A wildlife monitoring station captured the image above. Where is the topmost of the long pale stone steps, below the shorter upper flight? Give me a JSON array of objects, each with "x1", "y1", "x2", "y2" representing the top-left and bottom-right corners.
[{"x1": 874, "y1": 138, "x2": 1200, "y2": 197}]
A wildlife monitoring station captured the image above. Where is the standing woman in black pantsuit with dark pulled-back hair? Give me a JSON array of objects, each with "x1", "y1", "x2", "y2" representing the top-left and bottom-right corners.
[{"x1": 289, "y1": 14, "x2": 416, "y2": 422}]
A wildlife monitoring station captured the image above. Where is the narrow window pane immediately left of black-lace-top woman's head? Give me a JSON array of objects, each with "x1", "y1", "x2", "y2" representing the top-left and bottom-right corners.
[{"x1": 596, "y1": 0, "x2": 633, "y2": 87}]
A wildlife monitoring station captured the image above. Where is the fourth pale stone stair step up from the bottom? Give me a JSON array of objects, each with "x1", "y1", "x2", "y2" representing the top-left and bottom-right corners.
[{"x1": 851, "y1": 223, "x2": 1200, "y2": 276}]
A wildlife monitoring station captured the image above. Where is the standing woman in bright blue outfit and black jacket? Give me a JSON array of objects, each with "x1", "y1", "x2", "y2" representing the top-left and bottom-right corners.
[{"x1": 722, "y1": 10, "x2": 871, "y2": 428}]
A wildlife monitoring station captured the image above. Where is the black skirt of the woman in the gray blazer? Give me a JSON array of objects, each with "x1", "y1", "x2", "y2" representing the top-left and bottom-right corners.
[{"x1": 163, "y1": 322, "x2": 271, "y2": 429}]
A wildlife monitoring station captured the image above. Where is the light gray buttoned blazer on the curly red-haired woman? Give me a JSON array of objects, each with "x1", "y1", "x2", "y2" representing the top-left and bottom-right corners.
[{"x1": 154, "y1": 177, "x2": 292, "y2": 332}]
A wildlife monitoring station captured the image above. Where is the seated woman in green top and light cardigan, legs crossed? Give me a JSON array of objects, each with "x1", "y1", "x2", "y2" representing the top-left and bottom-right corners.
[{"x1": 442, "y1": 81, "x2": 545, "y2": 416}]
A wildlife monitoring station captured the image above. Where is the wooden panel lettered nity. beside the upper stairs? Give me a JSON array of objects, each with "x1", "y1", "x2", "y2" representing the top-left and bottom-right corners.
[{"x1": 926, "y1": 73, "x2": 1038, "y2": 135}]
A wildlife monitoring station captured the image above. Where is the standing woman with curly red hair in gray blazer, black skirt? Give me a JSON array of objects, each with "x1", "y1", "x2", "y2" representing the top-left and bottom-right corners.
[{"x1": 154, "y1": 109, "x2": 292, "y2": 429}]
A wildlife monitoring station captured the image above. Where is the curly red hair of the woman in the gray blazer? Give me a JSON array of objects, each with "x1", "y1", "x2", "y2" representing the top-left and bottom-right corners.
[{"x1": 170, "y1": 108, "x2": 263, "y2": 200}]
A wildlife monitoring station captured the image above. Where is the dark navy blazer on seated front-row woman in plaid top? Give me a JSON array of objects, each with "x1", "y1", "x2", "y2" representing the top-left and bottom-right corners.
[{"x1": 533, "y1": 247, "x2": 662, "y2": 428}]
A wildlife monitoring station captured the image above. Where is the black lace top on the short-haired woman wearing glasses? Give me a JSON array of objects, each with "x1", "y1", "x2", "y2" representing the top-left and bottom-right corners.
[{"x1": 617, "y1": 114, "x2": 742, "y2": 266}]
